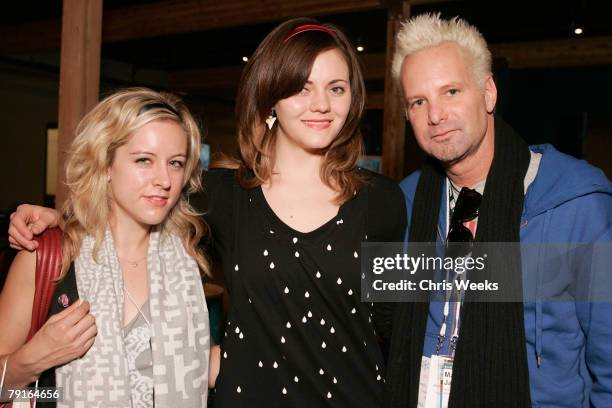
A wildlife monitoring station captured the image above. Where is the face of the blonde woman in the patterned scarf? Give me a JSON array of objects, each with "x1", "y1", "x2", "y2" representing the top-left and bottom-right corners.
[{"x1": 108, "y1": 120, "x2": 187, "y2": 228}]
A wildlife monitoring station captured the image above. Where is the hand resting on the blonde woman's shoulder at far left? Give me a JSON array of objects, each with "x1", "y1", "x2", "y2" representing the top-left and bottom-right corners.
[{"x1": 9, "y1": 204, "x2": 60, "y2": 251}]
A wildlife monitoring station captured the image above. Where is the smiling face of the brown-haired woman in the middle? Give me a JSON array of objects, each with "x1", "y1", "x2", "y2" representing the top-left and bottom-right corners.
[{"x1": 274, "y1": 49, "x2": 351, "y2": 152}]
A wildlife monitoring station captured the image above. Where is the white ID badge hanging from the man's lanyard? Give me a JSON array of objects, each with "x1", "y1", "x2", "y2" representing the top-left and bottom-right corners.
[{"x1": 417, "y1": 355, "x2": 453, "y2": 408}]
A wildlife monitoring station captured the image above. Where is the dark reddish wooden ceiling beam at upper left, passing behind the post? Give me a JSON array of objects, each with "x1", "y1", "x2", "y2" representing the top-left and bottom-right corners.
[{"x1": 0, "y1": 0, "x2": 385, "y2": 55}]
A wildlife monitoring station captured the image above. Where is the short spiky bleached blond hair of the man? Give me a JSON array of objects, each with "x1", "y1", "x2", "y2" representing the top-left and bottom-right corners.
[{"x1": 392, "y1": 13, "x2": 491, "y2": 87}]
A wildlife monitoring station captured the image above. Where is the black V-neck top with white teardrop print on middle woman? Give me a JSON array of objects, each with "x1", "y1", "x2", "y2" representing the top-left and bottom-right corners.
[{"x1": 193, "y1": 170, "x2": 405, "y2": 408}]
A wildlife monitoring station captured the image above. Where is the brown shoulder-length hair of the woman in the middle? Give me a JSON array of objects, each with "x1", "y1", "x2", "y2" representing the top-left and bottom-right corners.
[{"x1": 211, "y1": 18, "x2": 365, "y2": 204}]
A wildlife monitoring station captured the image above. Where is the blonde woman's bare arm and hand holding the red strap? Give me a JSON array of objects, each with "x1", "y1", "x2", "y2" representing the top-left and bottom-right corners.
[{"x1": 0, "y1": 251, "x2": 97, "y2": 389}]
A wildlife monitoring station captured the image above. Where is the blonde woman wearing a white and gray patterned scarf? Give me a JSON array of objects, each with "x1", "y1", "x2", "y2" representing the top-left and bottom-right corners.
[{"x1": 0, "y1": 89, "x2": 209, "y2": 407}]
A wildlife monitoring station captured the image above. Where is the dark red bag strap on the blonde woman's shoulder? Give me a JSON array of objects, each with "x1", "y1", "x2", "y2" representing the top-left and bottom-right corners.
[{"x1": 28, "y1": 227, "x2": 63, "y2": 340}]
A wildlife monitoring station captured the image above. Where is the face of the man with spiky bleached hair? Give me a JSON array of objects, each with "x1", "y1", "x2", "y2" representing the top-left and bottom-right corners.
[{"x1": 401, "y1": 43, "x2": 497, "y2": 164}]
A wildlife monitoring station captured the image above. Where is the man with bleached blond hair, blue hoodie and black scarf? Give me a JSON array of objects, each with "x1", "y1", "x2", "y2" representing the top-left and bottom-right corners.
[{"x1": 382, "y1": 14, "x2": 612, "y2": 408}]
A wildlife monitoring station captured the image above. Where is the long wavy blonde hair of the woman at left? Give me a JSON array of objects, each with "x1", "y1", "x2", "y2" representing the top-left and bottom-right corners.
[{"x1": 62, "y1": 88, "x2": 209, "y2": 276}]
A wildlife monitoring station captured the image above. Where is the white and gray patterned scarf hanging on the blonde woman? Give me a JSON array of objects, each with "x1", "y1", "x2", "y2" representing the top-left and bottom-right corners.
[{"x1": 55, "y1": 230, "x2": 210, "y2": 408}]
